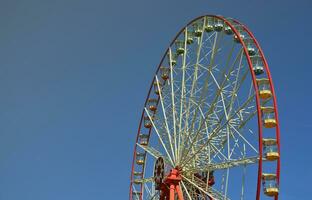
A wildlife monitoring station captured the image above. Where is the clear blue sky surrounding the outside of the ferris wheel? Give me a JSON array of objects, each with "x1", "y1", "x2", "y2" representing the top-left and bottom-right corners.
[{"x1": 0, "y1": 0, "x2": 312, "y2": 200}]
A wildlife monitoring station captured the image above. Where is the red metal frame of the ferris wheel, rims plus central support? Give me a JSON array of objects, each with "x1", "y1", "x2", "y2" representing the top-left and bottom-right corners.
[{"x1": 129, "y1": 15, "x2": 280, "y2": 200}]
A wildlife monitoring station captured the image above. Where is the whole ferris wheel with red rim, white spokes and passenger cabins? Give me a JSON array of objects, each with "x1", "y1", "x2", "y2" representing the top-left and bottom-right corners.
[{"x1": 129, "y1": 15, "x2": 280, "y2": 200}]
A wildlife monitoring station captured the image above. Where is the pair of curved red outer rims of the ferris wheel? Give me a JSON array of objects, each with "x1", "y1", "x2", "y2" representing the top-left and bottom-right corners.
[{"x1": 130, "y1": 15, "x2": 280, "y2": 200}]
